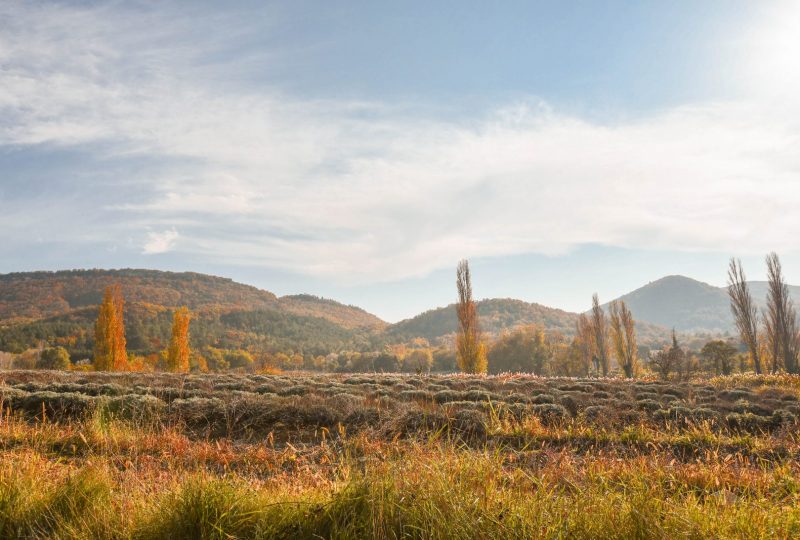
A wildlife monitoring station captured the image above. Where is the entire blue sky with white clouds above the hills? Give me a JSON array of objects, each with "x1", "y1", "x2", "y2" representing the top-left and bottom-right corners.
[{"x1": 0, "y1": 0, "x2": 800, "y2": 321}]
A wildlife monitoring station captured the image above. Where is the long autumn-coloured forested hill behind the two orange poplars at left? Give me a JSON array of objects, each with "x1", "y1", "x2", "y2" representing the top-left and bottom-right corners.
[{"x1": 0, "y1": 269, "x2": 385, "y2": 357}]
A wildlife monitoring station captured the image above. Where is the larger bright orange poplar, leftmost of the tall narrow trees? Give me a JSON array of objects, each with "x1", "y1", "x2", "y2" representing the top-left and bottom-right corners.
[{"x1": 94, "y1": 285, "x2": 128, "y2": 371}]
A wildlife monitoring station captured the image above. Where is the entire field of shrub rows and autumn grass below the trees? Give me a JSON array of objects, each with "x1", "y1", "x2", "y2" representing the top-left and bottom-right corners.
[{"x1": 0, "y1": 371, "x2": 800, "y2": 539}]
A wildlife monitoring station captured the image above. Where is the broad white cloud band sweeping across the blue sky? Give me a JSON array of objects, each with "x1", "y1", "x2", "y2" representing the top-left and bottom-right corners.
[{"x1": 0, "y1": 3, "x2": 800, "y2": 281}]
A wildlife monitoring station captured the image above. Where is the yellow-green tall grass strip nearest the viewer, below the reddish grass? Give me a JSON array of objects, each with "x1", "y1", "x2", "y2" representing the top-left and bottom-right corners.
[{"x1": 0, "y1": 441, "x2": 800, "y2": 540}]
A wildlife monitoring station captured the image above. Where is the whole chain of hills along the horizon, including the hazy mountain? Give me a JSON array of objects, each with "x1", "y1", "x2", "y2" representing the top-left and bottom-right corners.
[{"x1": 0, "y1": 268, "x2": 764, "y2": 354}]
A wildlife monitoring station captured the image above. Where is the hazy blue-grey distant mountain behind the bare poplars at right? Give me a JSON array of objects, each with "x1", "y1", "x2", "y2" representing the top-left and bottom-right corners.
[{"x1": 605, "y1": 276, "x2": 800, "y2": 332}]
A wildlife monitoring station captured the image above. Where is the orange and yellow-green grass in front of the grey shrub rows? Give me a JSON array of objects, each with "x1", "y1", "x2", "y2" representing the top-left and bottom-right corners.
[{"x1": 0, "y1": 376, "x2": 800, "y2": 540}]
